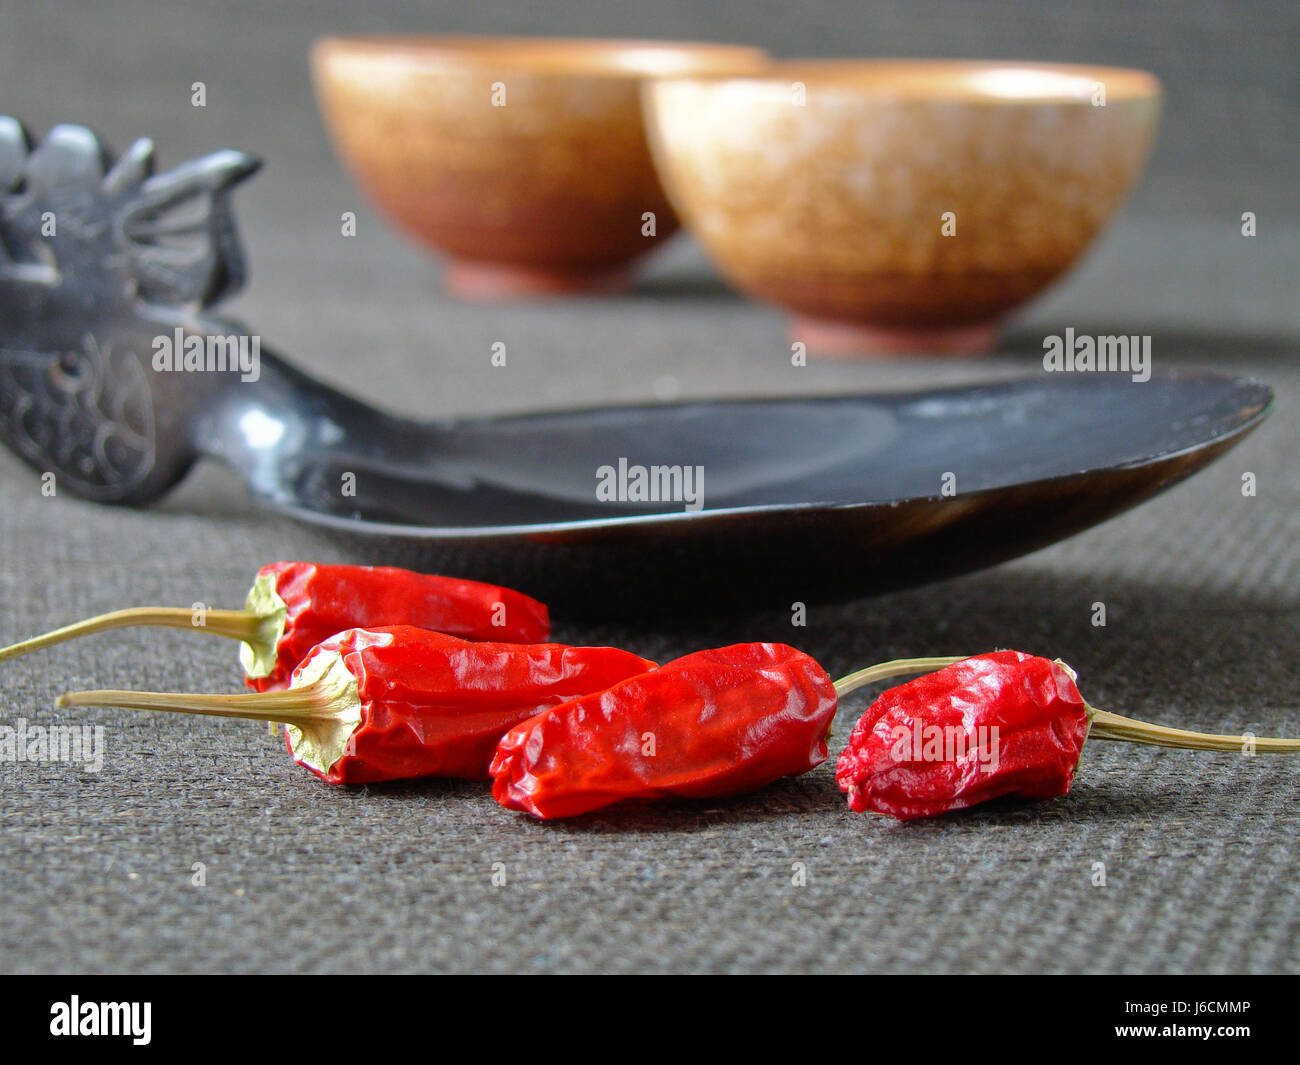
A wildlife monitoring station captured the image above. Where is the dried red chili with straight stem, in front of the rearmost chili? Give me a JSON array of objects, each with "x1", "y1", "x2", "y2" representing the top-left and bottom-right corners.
[{"x1": 59, "y1": 625, "x2": 654, "y2": 784}]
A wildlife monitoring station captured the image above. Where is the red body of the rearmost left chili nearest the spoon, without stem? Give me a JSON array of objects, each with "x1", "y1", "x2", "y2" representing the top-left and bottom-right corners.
[{"x1": 247, "y1": 562, "x2": 551, "y2": 692}]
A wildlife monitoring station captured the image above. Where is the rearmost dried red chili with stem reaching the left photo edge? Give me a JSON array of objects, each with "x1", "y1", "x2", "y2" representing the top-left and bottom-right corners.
[{"x1": 0, "y1": 562, "x2": 550, "y2": 692}]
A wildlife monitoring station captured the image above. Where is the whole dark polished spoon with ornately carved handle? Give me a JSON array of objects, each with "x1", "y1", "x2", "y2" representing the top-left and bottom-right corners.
[{"x1": 0, "y1": 117, "x2": 1271, "y2": 618}]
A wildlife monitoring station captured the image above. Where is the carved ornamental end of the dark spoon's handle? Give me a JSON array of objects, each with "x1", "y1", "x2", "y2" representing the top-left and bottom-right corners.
[{"x1": 0, "y1": 116, "x2": 259, "y2": 502}]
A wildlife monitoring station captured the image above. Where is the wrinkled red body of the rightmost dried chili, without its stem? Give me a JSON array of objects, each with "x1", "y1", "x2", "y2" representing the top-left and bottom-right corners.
[{"x1": 836, "y1": 650, "x2": 1089, "y2": 821}]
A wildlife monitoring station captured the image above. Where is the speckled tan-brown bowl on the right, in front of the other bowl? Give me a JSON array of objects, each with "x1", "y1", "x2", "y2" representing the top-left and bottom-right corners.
[{"x1": 645, "y1": 60, "x2": 1161, "y2": 355}]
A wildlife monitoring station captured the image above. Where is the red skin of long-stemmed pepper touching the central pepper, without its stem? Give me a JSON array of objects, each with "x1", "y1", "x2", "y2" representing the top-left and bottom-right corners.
[{"x1": 286, "y1": 625, "x2": 655, "y2": 784}]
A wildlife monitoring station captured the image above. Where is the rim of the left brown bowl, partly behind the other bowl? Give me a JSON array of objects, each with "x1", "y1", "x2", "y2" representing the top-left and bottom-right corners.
[{"x1": 312, "y1": 34, "x2": 771, "y2": 81}]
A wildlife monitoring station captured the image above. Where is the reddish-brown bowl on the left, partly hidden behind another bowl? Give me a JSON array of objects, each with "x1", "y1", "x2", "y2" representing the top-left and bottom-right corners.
[{"x1": 312, "y1": 36, "x2": 766, "y2": 296}]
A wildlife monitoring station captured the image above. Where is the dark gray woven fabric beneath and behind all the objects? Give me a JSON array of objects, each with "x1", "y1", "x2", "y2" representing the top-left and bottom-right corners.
[{"x1": 0, "y1": 0, "x2": 1300, "y2": 973}]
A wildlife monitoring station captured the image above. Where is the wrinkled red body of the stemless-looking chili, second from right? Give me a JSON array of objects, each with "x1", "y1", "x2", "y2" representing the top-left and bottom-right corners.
[{"x1": 491, "y1": 644, "x2": 837, "y2": 819}]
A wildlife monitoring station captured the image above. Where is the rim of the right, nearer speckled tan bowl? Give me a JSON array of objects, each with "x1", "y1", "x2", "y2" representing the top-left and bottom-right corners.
[{"x1": 646, "y1": 59, "x2": 1164, "y2": 107}]
